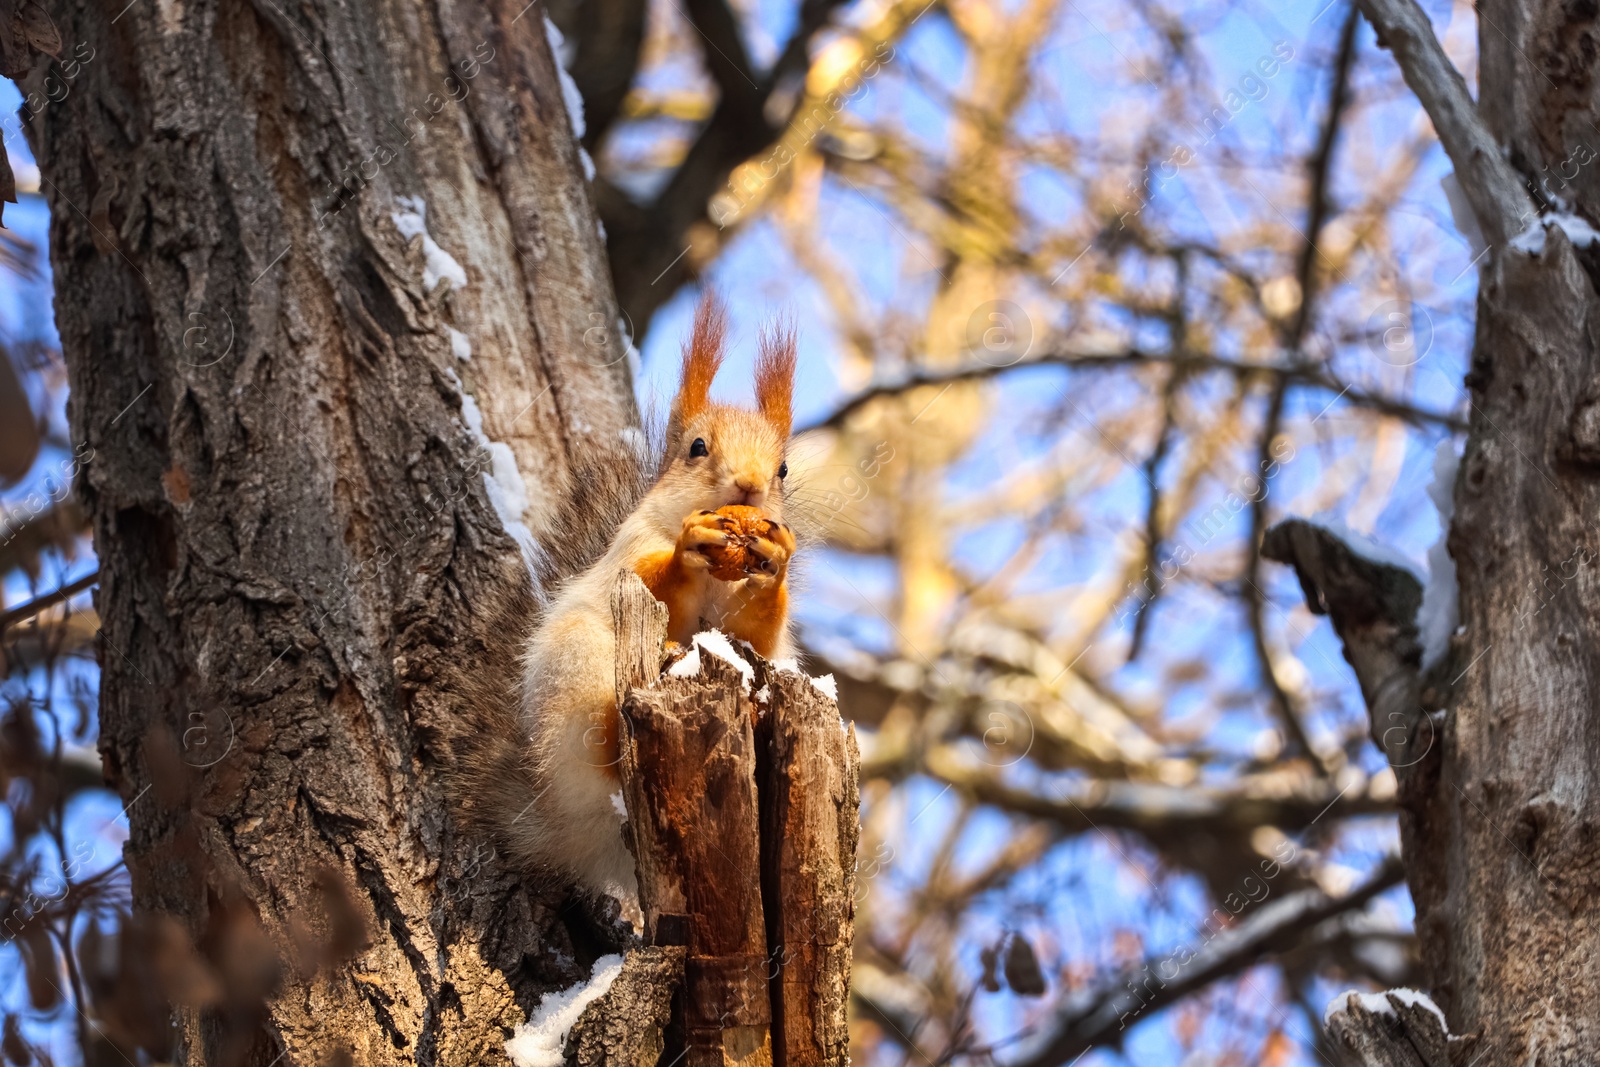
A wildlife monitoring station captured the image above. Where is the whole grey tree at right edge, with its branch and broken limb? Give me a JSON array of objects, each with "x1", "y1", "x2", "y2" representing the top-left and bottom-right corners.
[{"x1": 1269, "y1": 0, "x2": 1600, "y2": 1067}]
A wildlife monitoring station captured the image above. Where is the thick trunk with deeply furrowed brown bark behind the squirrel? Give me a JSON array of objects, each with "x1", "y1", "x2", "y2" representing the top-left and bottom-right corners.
[{"x1": 24, "y1": 0, "x2": 637, "y2": 1064}]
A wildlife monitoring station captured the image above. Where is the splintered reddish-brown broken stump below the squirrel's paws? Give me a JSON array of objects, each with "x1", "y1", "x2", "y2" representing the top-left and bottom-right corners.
[{"x1": 613, "y1": 574, "x2": 859, "y2": 1067}]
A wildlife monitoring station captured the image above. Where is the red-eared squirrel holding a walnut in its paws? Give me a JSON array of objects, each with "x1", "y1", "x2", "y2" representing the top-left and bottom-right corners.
[{"x1": 451, "y1": 296, "x2": 795, "y2": 907}]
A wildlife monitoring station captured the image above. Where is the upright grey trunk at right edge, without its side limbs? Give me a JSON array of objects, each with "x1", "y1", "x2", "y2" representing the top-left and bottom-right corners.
[{"x1": 1408, "y1": 0, "x2": 1600, "y2": 1067}]
